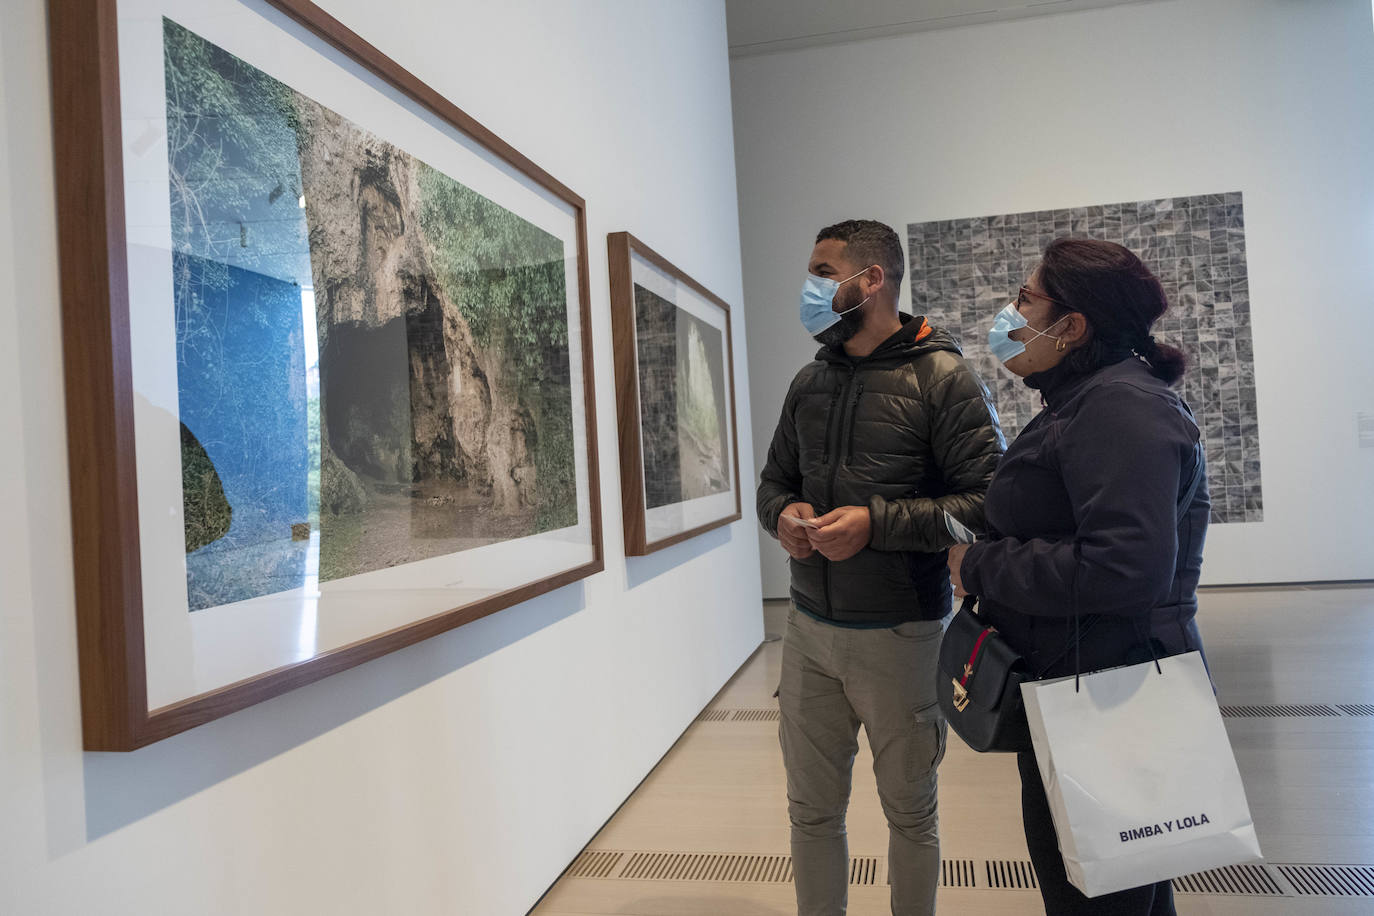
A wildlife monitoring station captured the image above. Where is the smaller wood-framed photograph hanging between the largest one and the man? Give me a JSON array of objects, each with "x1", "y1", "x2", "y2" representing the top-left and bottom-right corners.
[{"x1": 607, "y1": 232, "x2": 741, "y2": 556}]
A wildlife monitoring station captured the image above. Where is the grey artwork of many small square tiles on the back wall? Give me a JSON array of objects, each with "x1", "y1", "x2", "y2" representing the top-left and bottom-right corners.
[{"x1": 907, "y1": 192, "x2": 1264, "y2": 522}]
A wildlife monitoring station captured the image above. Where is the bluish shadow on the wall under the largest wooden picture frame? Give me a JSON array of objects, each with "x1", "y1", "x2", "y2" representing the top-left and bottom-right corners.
[{"x1": 79, "y1": 582, "x2": 587, "y2": 842}]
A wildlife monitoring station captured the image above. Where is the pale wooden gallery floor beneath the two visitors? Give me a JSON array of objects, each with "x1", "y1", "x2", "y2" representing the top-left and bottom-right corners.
[{"x1": 532, "y1": 588, "x2": 1374, "y2": 916}]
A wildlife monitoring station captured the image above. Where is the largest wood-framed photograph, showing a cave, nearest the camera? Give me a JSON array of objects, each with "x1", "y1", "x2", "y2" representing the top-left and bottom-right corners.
[{"x1": 49, "y1": 0, "x2": 603, "y2": 750}]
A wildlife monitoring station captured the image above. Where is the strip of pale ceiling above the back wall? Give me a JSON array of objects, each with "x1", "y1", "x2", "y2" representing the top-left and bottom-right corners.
[{"x1": 725, "y1": 0, "x2": 1151, "y2": 58}]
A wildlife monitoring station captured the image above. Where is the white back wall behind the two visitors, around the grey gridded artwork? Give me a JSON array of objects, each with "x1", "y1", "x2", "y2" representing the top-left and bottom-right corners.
[{"x1": 732, "y1": 0, "x2": 1374, "y2": 596}]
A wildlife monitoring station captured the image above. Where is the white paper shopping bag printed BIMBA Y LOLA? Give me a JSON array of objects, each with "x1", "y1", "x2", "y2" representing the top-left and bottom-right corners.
[{"x1": 1021, "y1": 652, "x2": 1261, "y2": 897}]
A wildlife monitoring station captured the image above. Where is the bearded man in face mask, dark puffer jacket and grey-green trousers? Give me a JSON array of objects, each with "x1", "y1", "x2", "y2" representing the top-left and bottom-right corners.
[{"x1": 758, "y1": 220, "x2": 1004, "y2": 916}]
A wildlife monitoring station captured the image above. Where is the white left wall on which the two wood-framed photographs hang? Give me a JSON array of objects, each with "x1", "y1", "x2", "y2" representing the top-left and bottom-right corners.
[{"x1": 0, "y1": 0, "x2": 763, "y2": 916}]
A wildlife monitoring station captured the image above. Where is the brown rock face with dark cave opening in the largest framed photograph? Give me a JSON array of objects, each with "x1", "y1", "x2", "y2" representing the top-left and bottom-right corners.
[{"x1": 298, "y1": 100, "x2": 534, "y2": 514}]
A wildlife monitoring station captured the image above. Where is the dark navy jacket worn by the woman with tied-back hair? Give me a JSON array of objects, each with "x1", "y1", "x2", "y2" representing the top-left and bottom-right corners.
[{"x1": 959, "y1": 357, "x2": 1210, "y2": 677}]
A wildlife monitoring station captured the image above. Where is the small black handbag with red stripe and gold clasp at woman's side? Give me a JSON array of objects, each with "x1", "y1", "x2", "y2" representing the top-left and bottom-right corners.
[{"x1": 936, "y1": 595, "x2": 1033, "y2": 751}]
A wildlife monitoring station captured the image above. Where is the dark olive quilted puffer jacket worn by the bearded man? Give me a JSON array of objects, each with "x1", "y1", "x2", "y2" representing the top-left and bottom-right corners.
[{"x1": 757, "y1": 314, "x2": 1006, "y2": 626}]
